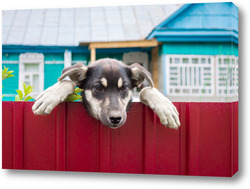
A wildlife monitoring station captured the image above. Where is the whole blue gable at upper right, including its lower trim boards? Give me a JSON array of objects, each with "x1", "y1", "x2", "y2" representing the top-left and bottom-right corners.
[{"x1": 147, "y1": 3, "x2": 238, "y2": 43}]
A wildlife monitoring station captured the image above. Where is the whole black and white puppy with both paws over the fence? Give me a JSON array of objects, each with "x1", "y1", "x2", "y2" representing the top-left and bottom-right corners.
[{"x1": 32, "y1": 59, "x2": 180, "y2": 129}]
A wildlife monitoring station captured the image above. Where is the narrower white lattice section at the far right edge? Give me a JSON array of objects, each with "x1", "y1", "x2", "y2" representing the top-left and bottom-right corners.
[{"x1": 216, "y1": 55, "x2": 238, "y2": 96}]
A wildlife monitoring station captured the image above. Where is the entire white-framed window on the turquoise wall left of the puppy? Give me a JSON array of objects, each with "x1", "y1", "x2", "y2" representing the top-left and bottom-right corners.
[{"x1": 19, "y1": 53, "x2": 44, "y2": 97}]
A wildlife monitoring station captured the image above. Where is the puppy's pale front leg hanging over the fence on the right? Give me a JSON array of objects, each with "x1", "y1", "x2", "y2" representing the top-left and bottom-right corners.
[{"x1": 139, "y1": 87, "x2": 180, "y2": 129}]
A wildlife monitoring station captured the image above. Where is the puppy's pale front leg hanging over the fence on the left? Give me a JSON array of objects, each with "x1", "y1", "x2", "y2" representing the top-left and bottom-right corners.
[{"x1": 32, "y1": 80, "x2": 75, "y2": 115}]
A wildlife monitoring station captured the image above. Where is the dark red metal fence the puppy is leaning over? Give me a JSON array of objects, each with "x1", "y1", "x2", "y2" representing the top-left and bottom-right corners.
[{"x1": 2, "y1": 102, "x2": 238, "y2": 177}]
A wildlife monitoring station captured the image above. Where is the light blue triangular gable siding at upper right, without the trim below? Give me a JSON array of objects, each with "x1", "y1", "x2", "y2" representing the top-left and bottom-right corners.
[{"x1": 166, "y1": 3, "x2": 238, "y2": 31}]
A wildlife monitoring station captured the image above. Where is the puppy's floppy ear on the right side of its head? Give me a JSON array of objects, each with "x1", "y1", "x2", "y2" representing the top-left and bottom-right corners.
[{"x1": 129, "y1": 63, "x2": 154, "y2": 87}]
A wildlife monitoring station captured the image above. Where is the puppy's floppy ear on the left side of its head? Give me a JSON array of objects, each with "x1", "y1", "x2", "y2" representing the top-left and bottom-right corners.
[{"x1": 58, "y1": 63, "x2": 88, "y2": 87}]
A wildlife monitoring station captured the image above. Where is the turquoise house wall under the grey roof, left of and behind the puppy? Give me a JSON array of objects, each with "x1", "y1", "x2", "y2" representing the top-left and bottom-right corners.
[{"x1": 2, "y1": 48, "x2": 150, "y2": 101}]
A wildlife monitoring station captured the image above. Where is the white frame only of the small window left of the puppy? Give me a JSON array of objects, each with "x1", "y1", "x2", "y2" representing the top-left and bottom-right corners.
[{"x1": 18, "y1": 53, "x2": 44, "y2": 97}]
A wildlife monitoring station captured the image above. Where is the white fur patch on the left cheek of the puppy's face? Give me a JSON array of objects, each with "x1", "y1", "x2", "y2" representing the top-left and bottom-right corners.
[{"x1": 85, "y1": 90, "x2": 101, "y2": 119}]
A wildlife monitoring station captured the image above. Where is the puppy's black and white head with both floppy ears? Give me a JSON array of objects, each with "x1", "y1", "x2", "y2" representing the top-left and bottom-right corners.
[{"x1": 58, "y1": 59, "x2": 153, "y2": 128}]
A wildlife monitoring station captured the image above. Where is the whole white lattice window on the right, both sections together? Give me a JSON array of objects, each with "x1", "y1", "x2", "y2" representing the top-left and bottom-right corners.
[{"x1": 165, "y1": 55, "x2": 238, "y2": 97}]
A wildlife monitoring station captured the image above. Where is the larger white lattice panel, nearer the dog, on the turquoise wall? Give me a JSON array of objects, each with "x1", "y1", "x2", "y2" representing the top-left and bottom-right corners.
[{"x1": 165, "y1": 55, "x2": 215, "y2": 96}]
